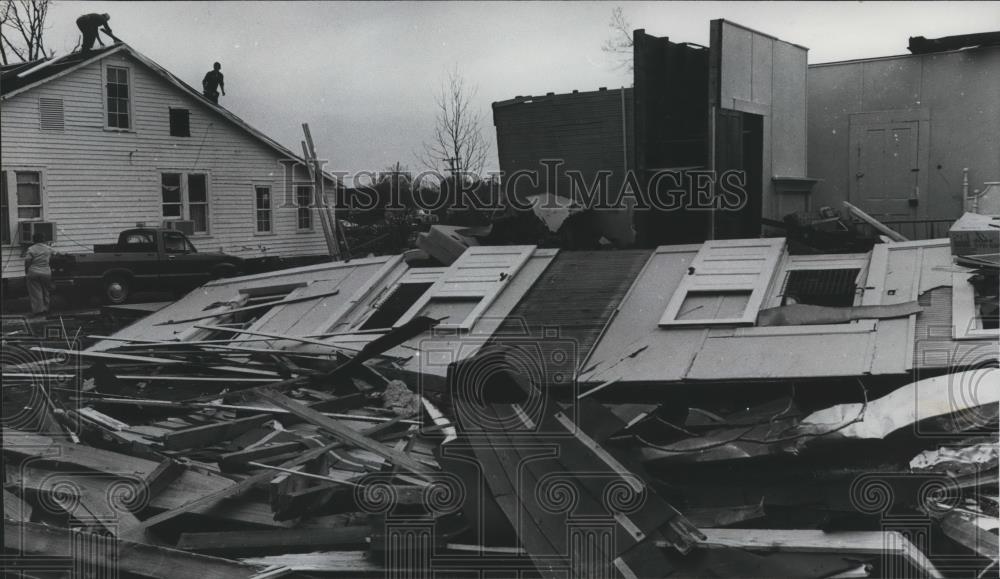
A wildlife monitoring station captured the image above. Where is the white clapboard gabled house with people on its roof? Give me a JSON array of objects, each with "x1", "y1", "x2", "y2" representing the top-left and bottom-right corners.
[{"x1": 0, "y1": 44, "x2": 332, "y2": 286}]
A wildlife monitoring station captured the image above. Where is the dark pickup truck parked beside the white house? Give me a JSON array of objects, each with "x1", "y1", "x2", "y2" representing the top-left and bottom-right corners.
[{"x1": 51, "y1": 228, "x2": 243, "y2": 304}]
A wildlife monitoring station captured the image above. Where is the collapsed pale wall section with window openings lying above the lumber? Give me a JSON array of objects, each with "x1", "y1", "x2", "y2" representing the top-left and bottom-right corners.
[{"x1": 93, "y1": 238, "x2": 997, "y2": 386}]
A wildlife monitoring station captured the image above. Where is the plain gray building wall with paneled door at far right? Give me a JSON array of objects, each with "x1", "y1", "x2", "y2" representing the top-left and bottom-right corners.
[{"x1": 808, "y1": 46, "x2": 1000, "y2": 232}]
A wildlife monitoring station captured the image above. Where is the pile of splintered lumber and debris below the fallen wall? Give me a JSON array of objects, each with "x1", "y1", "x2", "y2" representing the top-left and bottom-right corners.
[{"x1": 3, "y1": 256, "x2": 1000, "y2": 578}]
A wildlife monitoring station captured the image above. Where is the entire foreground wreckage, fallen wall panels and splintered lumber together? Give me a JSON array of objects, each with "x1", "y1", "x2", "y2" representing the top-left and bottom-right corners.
[{"x1": 3, "y1": 232, "x2": 1000, "y2": 578}]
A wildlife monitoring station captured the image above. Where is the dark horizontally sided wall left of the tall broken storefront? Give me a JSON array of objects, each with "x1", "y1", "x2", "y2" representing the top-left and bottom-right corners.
[{"x1": 493, "y1": 88, "x2": 633, "y2": 245}]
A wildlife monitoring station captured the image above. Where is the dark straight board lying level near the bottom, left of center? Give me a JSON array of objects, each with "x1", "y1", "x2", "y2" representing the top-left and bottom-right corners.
[{"x1": 177, "y1": 525, "x2": 371, "y2": 552}]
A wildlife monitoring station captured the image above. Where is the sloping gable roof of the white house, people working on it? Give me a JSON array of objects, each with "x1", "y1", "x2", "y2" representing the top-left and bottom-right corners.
[{"x1": 0, "y1": 42, "x2": 338, "y2": 183}]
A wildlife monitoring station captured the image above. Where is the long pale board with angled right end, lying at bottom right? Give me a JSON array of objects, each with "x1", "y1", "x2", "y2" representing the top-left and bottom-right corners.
[{"x1": 701, "y1": 529, "x2": 942, "y2": 577}]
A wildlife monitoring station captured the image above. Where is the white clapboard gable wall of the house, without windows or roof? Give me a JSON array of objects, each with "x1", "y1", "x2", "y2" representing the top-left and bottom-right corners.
[{"x1": 0, "y1": 50, "x2": 326, "y2": 278}]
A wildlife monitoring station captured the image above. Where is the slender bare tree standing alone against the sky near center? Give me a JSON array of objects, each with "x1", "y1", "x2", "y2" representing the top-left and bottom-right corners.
[{"x1": 418, "y1": 69, "x2": 489, "y2": 175}]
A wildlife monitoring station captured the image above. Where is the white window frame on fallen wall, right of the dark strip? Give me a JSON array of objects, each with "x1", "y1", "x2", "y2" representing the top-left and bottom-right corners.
[{"x1": 660, "y1": 238, "x2": 785, "y2": 326}]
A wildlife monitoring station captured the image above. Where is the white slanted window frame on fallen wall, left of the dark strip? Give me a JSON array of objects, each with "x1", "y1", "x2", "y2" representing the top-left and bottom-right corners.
[{"x1": 396, "y1": 245, "x2": 535, "y2": 330}]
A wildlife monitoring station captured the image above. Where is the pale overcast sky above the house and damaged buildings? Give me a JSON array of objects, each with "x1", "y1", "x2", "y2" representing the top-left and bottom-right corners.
[{"x1": 41, "y1": 1, "x2": 1000, "y2": 177}]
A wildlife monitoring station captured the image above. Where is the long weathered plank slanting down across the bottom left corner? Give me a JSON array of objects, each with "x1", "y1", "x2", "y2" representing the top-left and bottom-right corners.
[{"x1": 3, "y1": 520, "x2": 261, "y2": 579}]
